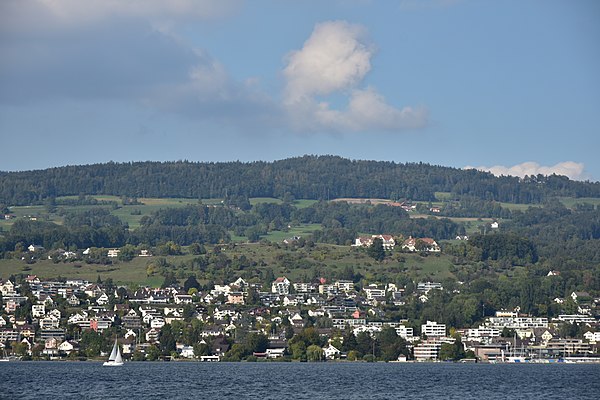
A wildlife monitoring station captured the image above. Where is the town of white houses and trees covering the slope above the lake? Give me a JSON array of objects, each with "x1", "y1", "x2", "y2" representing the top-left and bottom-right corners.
[{"x1": 0, "y1": 260, "x2": 600, "y2": 362}]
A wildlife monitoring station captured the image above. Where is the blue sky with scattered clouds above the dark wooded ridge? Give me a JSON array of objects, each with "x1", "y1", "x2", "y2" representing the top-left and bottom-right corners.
[{"x1": 0, "y1": 0, "x2": 600, "y2": 181}]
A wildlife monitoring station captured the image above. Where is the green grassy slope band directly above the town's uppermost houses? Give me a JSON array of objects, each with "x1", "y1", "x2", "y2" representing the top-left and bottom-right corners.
[{"x1": 0, "y1": 243, "x2": 452, "y2": 286}]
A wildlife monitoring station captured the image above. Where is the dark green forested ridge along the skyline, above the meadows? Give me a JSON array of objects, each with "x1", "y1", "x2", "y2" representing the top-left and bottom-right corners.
[{"x1": 0, "y1": 156, "x2": 600, "y2": 205}]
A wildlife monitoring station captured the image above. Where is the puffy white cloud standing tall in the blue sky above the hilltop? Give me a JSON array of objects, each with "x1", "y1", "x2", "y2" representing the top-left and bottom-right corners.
[{"x1": 283, "y1": 21, "x2": 427, "y2": 132}]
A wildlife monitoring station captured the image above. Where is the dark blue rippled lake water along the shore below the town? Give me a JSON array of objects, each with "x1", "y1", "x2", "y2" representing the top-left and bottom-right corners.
[{"x1": 0, "y1": 362, "x2": 600, "y2": 400}]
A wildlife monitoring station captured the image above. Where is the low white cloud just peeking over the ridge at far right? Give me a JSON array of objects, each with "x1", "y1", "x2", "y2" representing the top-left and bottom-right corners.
[{"x1": 465, "y1": 161, "x2": 586, "y2": 180}]
